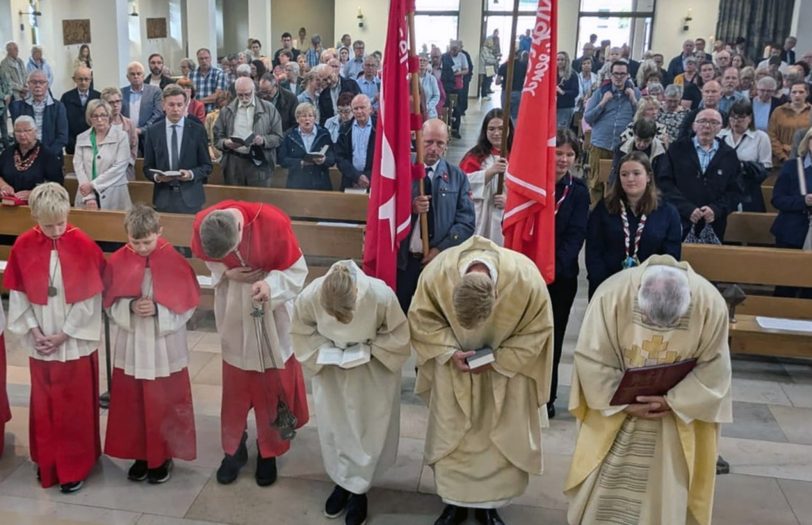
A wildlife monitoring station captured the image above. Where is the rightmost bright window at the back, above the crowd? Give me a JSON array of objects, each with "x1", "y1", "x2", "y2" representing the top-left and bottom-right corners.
[{"x1": 575, "y1": 0, "x2": 656, "y2": 57}]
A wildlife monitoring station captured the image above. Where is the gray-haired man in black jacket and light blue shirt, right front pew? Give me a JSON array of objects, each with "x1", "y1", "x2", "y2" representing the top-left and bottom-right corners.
[{"x1": 656, "y1": 109, "x2": 741, "y2": 241}]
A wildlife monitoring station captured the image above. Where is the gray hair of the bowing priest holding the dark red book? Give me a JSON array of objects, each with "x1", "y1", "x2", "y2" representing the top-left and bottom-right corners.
[{"x1": 637, "y1": 265, "x2": 691, "y2": 328}]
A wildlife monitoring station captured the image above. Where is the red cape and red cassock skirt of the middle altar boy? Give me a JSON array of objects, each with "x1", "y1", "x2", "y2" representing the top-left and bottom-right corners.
[{"x1": 104, "y1": 238, "x2": 200, "y2": 468}]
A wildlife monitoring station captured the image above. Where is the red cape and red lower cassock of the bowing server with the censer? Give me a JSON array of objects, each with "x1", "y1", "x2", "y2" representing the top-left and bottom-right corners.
[{"x1": 192, "y1": 200, "x2": 310, "y2": 458}]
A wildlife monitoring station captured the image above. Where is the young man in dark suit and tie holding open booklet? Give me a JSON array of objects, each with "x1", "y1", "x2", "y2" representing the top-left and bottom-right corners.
[{"x1": 144, "y1": 84, "x2": 211, "y2": 213}]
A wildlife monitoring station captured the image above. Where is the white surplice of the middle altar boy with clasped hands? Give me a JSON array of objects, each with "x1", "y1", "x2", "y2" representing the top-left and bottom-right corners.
[{"x1": 107, "y1": 268, "x2": 195, "y2": 380}]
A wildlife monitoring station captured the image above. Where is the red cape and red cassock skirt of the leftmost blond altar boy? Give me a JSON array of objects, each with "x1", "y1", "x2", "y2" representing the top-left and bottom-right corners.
[{"x1": 4, "y1": 225, "x2": 104, "y2": 487}]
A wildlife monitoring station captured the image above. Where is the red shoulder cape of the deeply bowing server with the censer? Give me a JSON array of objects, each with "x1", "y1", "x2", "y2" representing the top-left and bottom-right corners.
[{"x1": 192, "y1": 200, "x2": 302, "y2": 272}]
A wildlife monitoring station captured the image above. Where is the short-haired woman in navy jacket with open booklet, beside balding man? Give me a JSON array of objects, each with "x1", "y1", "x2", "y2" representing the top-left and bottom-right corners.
[{"x1": 279, "y1": 102, "x2": 335, "y2": 191}]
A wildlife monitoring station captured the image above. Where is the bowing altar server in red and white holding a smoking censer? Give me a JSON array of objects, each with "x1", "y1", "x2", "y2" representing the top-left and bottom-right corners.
[{"x1": 192, "y1": 200, "x2": 309, "y2": 486}]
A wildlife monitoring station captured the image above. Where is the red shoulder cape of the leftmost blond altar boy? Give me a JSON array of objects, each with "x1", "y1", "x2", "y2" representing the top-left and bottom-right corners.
[{"x1": 3, "y1": 224, "x2": 105, "y2": 305}]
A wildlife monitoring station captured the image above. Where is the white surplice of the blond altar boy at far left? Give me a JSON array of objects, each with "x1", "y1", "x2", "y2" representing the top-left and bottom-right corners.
[{"x1": 8, "y1": 250, "x2": 102, "y2": 362}]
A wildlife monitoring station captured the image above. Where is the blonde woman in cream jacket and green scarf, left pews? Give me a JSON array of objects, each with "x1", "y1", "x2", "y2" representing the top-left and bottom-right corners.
[{"x1": 73, "y1": 99, "x2": 132, "y2": 210}]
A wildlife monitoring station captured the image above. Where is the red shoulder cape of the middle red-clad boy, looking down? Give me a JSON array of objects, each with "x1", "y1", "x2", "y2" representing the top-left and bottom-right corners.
[{"x1": 104, "y1": 238, "x2": 200, "y2": 314}]
